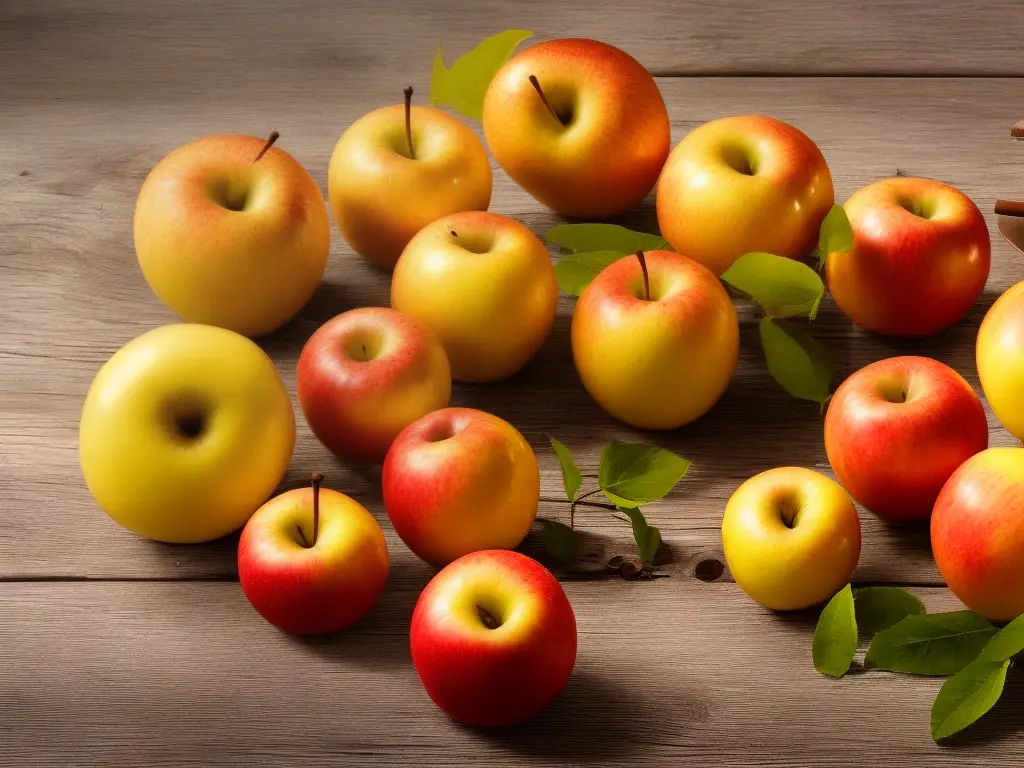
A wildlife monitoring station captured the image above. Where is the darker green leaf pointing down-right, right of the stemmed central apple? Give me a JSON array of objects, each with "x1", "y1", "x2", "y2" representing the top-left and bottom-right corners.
[{"x1": 760, "y1": 317, "x2": 833, "y2": 407}]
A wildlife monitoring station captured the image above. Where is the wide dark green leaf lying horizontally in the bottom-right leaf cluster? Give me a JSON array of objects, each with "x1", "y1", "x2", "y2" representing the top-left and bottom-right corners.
[{"x1": 864, "y1": 610, "x2": 995, "y2": 675}]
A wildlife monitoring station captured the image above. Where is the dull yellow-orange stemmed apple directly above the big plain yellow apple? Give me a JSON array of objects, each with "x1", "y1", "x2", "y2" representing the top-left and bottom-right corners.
[{"x1": 134, "y1": 132, "x2": 331, "y2": 337}]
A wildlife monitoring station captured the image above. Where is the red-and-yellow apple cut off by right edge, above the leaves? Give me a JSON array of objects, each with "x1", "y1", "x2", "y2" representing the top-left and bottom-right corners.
[{"x1": 932, "y1": 447, "x2": 1024, "y2": 621}]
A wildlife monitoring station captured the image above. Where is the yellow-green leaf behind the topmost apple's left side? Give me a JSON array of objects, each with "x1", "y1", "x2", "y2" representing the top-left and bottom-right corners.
[{"x1": 430, "y1": 30, "x2": 534, "y2": 120}]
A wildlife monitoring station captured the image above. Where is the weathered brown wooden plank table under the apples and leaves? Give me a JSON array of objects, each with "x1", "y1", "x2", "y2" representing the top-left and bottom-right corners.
[{"x1": 6, "y1": 0, "x2": 1024, "y2": 768}]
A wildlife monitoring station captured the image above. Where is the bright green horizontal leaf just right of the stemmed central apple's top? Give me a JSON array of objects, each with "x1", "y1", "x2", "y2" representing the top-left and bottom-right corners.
[{"x1": 722, "y1": 252, "x2": 825, "y2": 319}]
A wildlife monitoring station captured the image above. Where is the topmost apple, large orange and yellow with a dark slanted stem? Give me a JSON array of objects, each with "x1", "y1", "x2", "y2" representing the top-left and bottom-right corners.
[{"x1": 483, "y1": 39, "x2": 671, "y2": 219}]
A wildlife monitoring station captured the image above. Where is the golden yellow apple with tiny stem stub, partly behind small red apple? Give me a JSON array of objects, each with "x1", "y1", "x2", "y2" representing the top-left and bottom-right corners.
[{"x1": 391, "y1": 212, "x2": 558, "y2": 382}]
